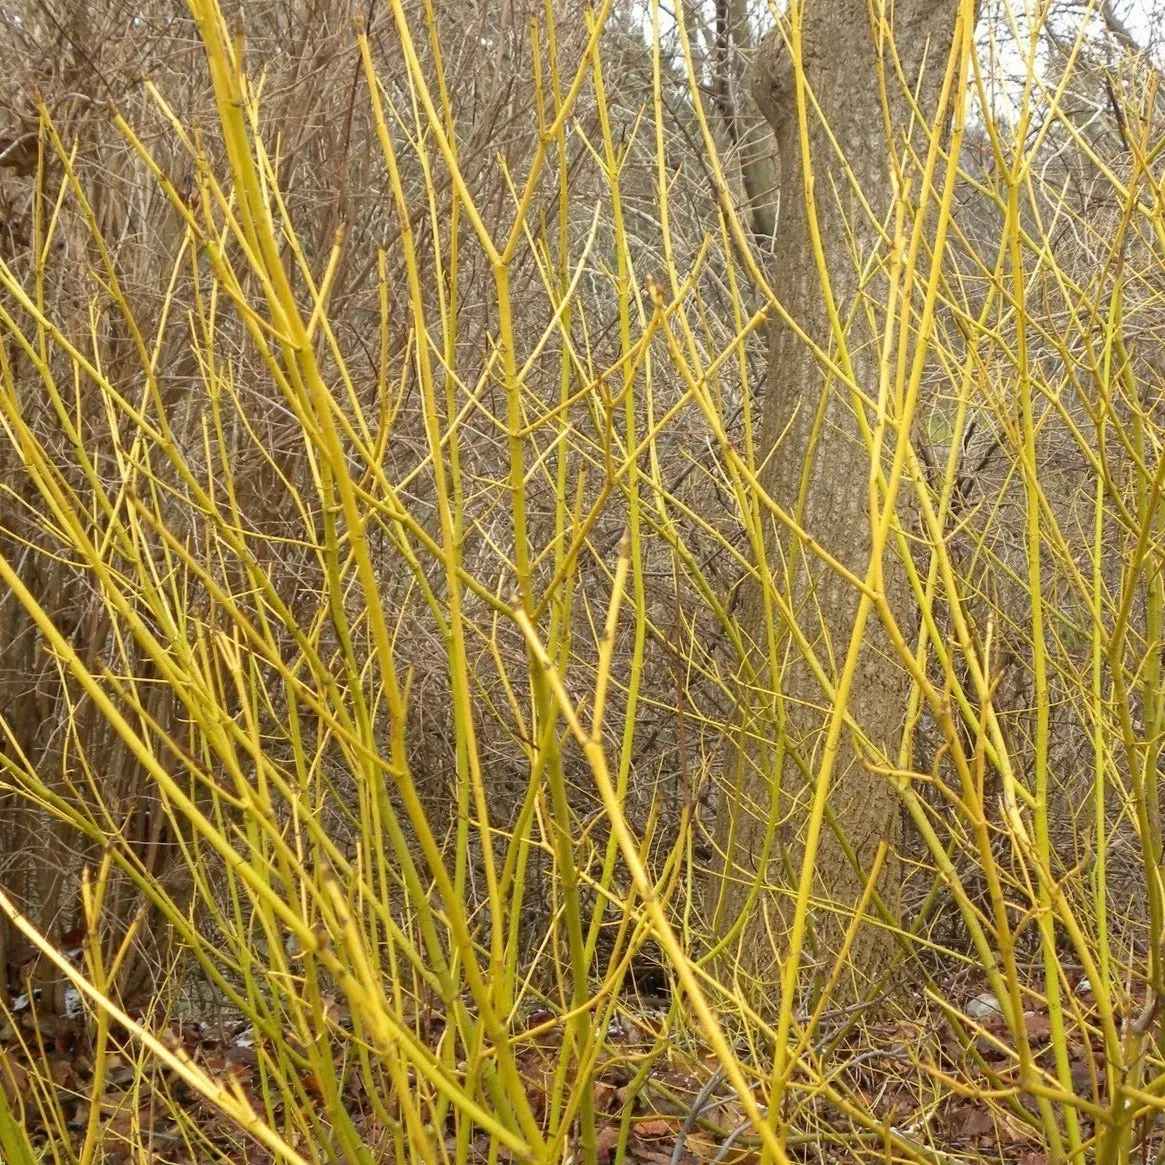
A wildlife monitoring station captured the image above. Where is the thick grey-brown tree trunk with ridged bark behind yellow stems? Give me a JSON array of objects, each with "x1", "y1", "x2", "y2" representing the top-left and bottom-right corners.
[{"x1": 714, "y1": 0, "x2": 960, "y2": 997}]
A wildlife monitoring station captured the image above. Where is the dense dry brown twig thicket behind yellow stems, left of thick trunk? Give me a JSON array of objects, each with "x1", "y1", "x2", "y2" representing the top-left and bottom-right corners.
[{"x1": 0, "y1": 0, "x2": 763, "y2": 1001}]
